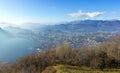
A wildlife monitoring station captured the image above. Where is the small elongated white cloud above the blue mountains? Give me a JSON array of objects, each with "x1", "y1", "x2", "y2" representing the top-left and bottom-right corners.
[{"x1": 68, "y1": 10, "x2": 104, "y2": 18}]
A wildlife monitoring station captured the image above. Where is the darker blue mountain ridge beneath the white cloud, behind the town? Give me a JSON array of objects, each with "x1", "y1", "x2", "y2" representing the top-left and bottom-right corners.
[{"x1": 41, "y1": 20, "x2": 120, "y2": 32}]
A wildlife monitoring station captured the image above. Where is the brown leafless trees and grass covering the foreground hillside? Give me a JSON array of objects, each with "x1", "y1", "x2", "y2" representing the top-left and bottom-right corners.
[{"x1": 0, "y1": 36, "x2": 120, "y2": 73}]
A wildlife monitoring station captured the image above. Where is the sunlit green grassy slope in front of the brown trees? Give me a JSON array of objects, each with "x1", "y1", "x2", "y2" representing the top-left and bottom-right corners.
[{"x1": 45, "y1": 65, "x2": 120, "y2": 73}]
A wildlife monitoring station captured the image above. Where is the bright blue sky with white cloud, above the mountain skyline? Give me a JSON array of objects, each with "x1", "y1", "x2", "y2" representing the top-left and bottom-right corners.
[{"x1": 0, "y1": 0, "x2": 120, "y2": 24}]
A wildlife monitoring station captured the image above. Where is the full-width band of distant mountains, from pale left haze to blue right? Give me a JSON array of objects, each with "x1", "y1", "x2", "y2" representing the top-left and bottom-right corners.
[{"x1": 0, "y1": 20, "x2": 120, "y2": 32}]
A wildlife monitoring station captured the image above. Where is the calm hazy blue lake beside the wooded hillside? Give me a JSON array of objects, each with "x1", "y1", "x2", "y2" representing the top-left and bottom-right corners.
[{"x1": 0, "y1": 38, "x2": 39, "y2": 62}]
